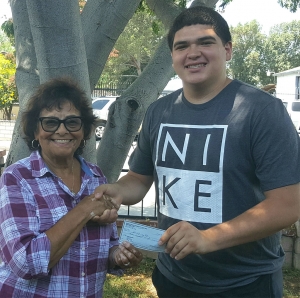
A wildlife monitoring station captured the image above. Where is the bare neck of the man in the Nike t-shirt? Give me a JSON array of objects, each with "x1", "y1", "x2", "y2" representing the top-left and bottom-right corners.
[{"x1": 183, "y1": 77, "x2": 232, "y2": 104}]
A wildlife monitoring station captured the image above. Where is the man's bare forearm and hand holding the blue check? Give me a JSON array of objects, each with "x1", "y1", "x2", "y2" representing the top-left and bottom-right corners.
[{"x1": 160, "y1": 183, "x2": 300, "y2": 260}]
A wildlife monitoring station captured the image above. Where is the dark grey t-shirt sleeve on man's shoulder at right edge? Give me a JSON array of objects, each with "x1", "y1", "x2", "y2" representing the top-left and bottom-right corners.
[{"x1": 251, "y1": 99, "x2": 300, "y2": 191}]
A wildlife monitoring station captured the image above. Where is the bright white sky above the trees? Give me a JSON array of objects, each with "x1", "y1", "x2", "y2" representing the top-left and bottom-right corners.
[{"x1": 0, "y1": 0, "x2": 300, "y2": 34}]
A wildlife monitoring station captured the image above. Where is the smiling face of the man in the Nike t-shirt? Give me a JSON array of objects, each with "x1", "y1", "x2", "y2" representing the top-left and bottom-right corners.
[{"x1": 172, "y1": 25, "x2": 232, "y2": 87}]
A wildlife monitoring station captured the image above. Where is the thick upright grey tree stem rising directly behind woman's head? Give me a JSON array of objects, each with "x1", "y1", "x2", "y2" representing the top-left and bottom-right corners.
[{"x1": 27, "y1": 0, "x2": 96, "y2": 163}]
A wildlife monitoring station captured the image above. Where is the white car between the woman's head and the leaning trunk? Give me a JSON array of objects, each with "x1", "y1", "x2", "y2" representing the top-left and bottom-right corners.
[{"x1": 92, "y1": 97, "x2": 117, "y2": 140}]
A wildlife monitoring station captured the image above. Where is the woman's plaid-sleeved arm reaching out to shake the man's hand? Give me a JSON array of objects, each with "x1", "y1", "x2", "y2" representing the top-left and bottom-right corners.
[{"x1": 0, "y1": 170, "x2": 112, "y2": 279}]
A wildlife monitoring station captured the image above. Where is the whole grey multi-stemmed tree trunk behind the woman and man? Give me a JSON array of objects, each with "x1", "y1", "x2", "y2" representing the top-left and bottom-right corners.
[{"x1": 7, "y1": 0, "x2": 217, "y2": 182}]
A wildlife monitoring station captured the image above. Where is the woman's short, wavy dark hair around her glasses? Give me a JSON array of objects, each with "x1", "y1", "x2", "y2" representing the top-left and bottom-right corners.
[{"x1": 21, "y1": 77, "x2": 97, "y2": 154}]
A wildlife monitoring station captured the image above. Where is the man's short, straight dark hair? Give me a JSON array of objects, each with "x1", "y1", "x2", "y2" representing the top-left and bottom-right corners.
[{"x1": 168, "y1": 6, "x2": 231, "y2": 52}]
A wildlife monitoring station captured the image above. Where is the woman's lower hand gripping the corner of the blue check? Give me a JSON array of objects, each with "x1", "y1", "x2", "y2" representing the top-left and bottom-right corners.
[{"x1": 112, "y1": 241, "x2": 143, "y2": 269}]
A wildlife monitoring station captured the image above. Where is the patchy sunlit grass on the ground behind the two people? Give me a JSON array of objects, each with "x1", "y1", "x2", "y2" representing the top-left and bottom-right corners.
[{"x1": 103, "y1": 258, "x2": 300, "y2": 298}]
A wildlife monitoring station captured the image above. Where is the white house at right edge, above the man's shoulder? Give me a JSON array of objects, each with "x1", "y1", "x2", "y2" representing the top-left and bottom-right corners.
[{"x1": 274, "y1": 66, "x2": 300, "y2": 101}]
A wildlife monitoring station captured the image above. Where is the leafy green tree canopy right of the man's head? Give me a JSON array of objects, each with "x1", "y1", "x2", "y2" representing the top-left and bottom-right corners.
[{"x1": 228, "y1": 20, "x2": 300, "y2": 87}]
